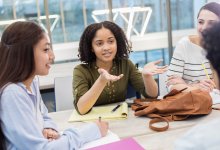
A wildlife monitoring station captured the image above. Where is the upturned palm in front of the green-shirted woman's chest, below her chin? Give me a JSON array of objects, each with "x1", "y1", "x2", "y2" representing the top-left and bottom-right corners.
[{"x1": 98, "y1": 68, "x2": 124, "y2": 83}]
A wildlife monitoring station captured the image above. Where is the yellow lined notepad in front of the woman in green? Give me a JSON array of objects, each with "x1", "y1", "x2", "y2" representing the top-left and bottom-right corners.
[{"x1": 68, "y1": 102, "x2": 128, "y2": 122}]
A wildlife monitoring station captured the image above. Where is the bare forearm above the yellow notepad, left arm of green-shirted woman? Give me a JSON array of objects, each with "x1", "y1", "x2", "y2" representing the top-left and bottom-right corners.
[{"x1": 77, "y1": 77, "x2": 107, "y2": 114}]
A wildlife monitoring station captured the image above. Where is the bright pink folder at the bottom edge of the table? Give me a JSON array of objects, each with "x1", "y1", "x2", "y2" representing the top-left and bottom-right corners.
[{"x1": 88, "y1": 138, "x2": 144, "y2": 150}]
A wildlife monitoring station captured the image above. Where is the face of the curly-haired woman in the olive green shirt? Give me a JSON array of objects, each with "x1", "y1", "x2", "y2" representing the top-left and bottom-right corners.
[{"x1": 92, "y1": 27, "x2": 117, "y2": 67}]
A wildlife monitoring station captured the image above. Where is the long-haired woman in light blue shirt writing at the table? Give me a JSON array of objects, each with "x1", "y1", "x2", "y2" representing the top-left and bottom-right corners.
[{"x1": 0, "y1": 22, "x2": 108, "y2": 150}]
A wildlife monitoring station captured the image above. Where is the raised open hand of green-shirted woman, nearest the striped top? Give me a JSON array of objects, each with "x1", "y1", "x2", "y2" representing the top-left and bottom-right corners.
[{"x1": 142, "y1": 59, "x2": 168, "y2": 76}]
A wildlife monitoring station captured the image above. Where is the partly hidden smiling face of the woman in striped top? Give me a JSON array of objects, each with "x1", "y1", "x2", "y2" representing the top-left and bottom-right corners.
[{"x1": 197, "y1": 9, "x2": 220, "y2": 37}]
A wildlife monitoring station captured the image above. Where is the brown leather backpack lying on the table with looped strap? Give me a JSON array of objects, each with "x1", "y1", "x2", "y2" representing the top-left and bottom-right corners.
[{"x1": 131, "y1": 89, "x2": 212, "y2": 131}]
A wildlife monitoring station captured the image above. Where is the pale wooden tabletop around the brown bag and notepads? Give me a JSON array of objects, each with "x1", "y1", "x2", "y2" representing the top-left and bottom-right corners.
[{"x1": 49, "y1": 109, "x2": 220, "y2": 150}]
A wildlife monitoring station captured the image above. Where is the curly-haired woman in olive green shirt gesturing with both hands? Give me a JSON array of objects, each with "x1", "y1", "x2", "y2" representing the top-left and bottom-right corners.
[{"x1": 73, "y1": 21, "x2": 167, "y2": 114}]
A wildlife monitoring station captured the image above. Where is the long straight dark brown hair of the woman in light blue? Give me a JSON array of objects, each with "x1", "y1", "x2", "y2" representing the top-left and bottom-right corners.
[{"x1": 0, "y1": 21, "x2": 45, "y2": 149}]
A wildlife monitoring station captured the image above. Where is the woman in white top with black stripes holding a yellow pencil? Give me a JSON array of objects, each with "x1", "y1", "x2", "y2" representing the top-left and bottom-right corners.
[{"x1": 167, "y1": 2, "x2": 220, "y2": 92}]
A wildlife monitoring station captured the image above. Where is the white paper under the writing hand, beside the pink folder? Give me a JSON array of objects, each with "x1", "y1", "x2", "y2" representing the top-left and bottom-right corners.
[{"x1": 80, "y1": 130, "x2": 120, "y2": 150}]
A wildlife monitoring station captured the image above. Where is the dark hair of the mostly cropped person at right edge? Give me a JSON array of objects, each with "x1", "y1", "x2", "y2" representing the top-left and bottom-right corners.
[{"x1": 202, "y1": 22, "x2": 220, "y2": 83}]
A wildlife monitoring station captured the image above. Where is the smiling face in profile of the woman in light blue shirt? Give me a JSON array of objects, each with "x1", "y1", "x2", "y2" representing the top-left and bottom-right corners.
[{"x1": 34, "y1": 33, "x2": 54, "y2": 75}]
